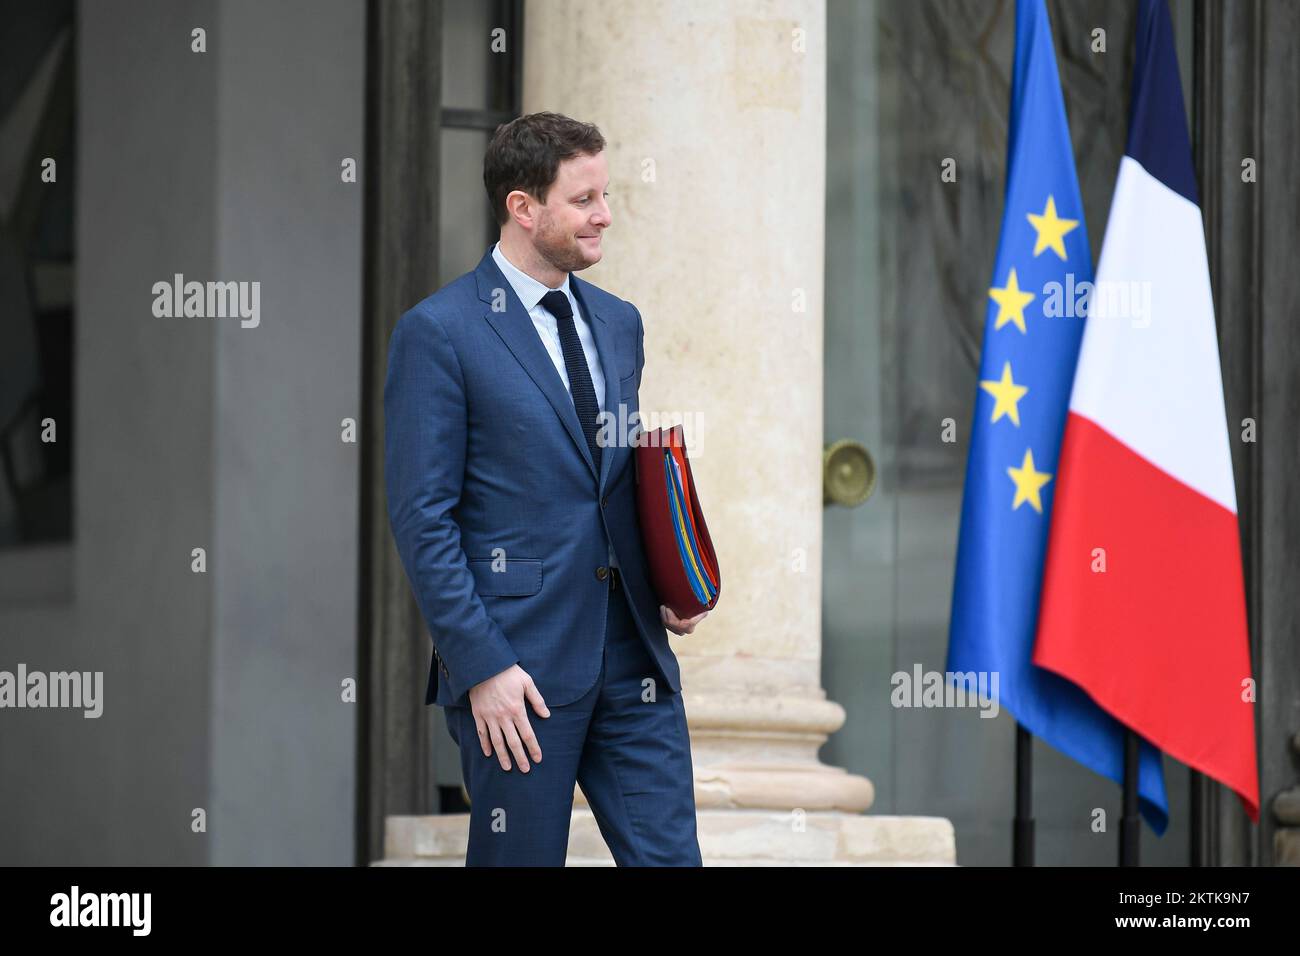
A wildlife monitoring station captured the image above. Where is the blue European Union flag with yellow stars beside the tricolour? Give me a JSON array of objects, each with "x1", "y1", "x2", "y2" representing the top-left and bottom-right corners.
[{"x1": 948, "y1": 0, "x2": 1169, "y2": 834}]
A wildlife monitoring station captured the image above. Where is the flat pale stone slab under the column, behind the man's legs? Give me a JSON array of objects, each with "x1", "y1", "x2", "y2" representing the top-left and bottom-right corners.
[{"x1": 372, "y1": 809, "x2": 957, "y2": 866}]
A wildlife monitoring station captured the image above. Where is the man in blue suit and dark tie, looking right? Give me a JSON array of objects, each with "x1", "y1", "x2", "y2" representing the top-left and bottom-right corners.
[{"x1": 384, "y1": 113, "x2": 707, "y2": 866}]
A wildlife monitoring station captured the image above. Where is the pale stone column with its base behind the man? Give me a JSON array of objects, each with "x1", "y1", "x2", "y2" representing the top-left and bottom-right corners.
[{"x1": 385, "y1": 0, "x2": 954, "y2": 865}]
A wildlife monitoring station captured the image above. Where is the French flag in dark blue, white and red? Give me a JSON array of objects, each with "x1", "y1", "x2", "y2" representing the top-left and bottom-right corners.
[{"x1": 1034, "y1": 0, "x2": 1260, "y2": 822}]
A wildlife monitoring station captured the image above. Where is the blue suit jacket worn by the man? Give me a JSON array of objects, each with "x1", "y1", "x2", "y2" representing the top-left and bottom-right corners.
[{"x1": 384, "y1": 248, "x2": 681, "y2": 708}]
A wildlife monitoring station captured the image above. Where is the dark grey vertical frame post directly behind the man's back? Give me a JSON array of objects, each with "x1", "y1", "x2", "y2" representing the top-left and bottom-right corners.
[{"x1": 356, "y1": 0, "x2": 442, "y2": 865}]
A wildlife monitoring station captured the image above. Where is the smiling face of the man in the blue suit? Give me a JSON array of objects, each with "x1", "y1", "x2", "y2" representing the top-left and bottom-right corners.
[{"x1": 533, "y1": 151, "x2": 610, "y2": 272}]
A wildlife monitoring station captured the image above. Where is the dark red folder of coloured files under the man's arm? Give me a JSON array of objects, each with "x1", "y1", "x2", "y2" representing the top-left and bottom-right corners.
[{"x1": 633, "y1": 425, "x2": 722, "y2": 619}]
